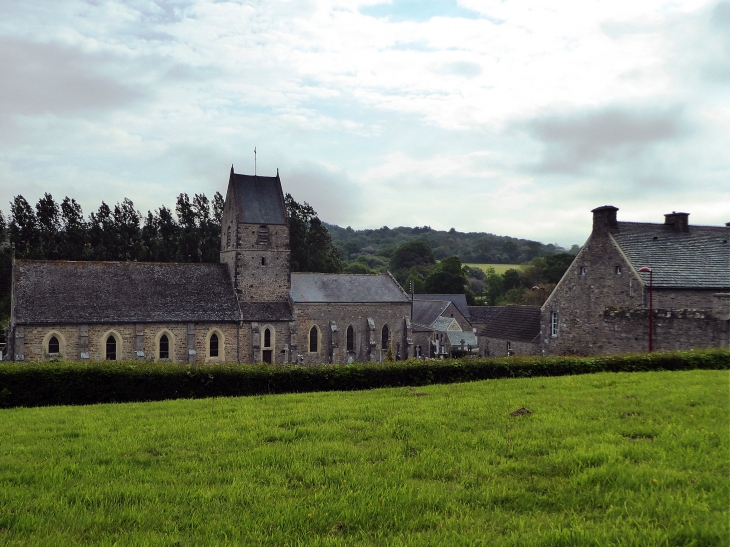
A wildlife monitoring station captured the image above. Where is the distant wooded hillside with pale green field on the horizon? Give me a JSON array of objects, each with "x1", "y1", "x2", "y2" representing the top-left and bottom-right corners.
[{"x1": 323, "y1": 222, "x2": 579, "y2": 264}]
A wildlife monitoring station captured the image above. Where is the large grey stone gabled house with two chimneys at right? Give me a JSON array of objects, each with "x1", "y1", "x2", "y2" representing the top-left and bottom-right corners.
[{"x1": 541, "y1": 205, "x2": 730, "y2": 355}]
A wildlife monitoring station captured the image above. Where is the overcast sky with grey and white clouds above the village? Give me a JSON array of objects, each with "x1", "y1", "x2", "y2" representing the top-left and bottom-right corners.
[{"x1": 0, "y1": 0, "x2": 730, "y2": 245}]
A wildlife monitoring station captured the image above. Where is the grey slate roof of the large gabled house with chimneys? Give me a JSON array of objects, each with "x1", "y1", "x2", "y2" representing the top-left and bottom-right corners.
[{"x1": 611, "y1": 222, "x2": 730, "y2": 289}]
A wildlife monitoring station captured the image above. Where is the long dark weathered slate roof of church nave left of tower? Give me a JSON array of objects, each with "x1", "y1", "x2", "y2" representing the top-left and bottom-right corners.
[{"x1": 14, "y1": 260, "x2": 239, "y2": 324}]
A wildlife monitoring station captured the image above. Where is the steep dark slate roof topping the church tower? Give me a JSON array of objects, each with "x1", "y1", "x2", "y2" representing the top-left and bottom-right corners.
[{"x1": 228, "y1": 168, "x2": 287, "y2": 224}]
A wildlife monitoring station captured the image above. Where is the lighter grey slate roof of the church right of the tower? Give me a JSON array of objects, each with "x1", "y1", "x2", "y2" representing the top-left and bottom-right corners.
[{"x1": 290, "y1": 273, "x2": 410, "y2": 303}]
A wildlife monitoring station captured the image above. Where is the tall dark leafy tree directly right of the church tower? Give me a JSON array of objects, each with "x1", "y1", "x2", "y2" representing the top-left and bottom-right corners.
[{"x1": 284, "y1": 194, "x2": 342, "y2": 273}]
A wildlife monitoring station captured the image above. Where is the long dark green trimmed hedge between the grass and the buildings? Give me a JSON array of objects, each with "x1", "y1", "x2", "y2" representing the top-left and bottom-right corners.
[{"x1": 0, "y1": 349, "x2": 730, "y2": 408}]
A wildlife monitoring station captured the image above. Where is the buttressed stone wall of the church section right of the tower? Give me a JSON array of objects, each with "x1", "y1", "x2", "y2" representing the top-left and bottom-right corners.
[{"x1": 292, "y1": 302, "x2": 413, "y2": 364}]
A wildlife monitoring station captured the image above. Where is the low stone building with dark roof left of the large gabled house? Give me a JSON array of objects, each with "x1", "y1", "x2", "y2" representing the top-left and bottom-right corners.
[{"x1": 478, "y1": 306, "x2": 540, "y2": 357}]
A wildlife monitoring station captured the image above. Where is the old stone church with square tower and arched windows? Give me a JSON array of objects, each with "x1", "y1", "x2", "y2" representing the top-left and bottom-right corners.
[{"x1": 6, "y1": 167, "x2": 413, "y2": 364}]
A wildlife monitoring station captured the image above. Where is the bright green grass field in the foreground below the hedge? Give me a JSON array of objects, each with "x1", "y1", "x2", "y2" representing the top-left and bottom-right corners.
[{"x1": 0, "y1": 371, "x2": 730, "y2": 547}]
